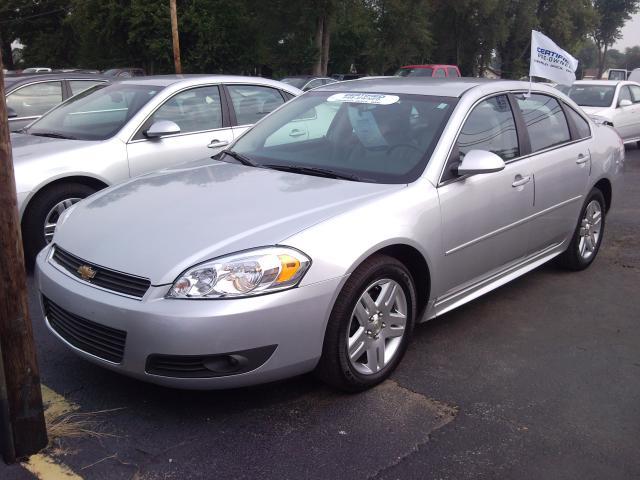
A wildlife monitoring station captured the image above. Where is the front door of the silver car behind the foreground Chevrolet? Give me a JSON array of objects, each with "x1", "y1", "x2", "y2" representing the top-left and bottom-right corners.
[{"x1": 127, "y1": 85, "x2": 233, "y2": 176}]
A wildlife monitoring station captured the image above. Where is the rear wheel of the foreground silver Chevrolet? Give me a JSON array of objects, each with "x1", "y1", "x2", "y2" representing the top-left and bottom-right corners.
[{"x1": 558, "y1": 188, "x2": 606, "y2": 271}]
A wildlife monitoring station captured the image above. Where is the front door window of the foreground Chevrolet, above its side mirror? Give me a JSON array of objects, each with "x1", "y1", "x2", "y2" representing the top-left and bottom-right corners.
[{"x1": 456, "y1": 95, "x2": 520, "y2": 161}]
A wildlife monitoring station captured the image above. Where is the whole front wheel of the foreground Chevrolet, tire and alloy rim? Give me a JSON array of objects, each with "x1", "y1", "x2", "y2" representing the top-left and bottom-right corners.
[{"x1": 316, "y1": 255, "x2": 416, "y2": 392}]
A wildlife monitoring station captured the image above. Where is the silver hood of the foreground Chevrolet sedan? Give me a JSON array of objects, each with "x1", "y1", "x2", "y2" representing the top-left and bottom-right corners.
[{"x1": 54, "y1": 159, "x2": 404, "y2": 285}]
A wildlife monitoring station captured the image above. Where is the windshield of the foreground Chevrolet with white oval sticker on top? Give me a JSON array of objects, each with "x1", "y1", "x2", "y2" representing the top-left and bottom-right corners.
[{"x1": 232, "y1": 92, "x2": 457, "y2": 183}]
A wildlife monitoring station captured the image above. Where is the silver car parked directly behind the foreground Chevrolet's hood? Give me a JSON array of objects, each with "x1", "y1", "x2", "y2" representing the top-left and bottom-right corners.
[{"x1": 9, "y1": 75, "x2": 301, "y2": 261}]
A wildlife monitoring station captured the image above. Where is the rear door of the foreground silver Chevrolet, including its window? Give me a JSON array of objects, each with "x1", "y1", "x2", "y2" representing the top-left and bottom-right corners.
[{"x1": 517, "y1": 94, "x2": 591, "y2": 252}]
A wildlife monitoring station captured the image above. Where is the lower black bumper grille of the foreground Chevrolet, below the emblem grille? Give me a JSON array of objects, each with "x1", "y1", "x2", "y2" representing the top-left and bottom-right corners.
[{"x1": 42, "y1": 297, "x2": 127, "y2": 363}]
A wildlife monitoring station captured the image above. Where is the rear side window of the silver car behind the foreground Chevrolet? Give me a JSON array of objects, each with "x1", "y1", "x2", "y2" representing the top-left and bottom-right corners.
[{"x1": 227, "y1": 85, "x2": 284, "y2": 125}]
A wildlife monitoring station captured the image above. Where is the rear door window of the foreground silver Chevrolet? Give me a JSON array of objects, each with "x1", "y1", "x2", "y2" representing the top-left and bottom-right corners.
[{"x1": 517, "y1": 94, "x2": 571, "y2": 152}]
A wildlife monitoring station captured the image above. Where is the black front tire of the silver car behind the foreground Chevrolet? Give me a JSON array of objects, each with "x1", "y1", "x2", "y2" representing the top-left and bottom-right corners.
[{"x1": 22, "y1": 183, "x2": 96, "y2": 268}]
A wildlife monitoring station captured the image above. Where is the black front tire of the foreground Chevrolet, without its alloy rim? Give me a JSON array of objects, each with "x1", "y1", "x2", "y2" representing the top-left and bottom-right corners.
[{"x1": 315, "y1": 255, "x2": 416, "y2": 392}]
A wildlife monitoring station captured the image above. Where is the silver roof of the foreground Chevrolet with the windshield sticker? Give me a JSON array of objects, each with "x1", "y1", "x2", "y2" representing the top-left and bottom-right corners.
[{"x1": 313, "y1": 77, "x2": 500, "y2": 97}]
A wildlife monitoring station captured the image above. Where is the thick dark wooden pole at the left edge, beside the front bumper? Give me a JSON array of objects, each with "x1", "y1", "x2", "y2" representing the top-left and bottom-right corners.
[{"x1": 0, "y1": 52, "x2": 47, "y2": 463}]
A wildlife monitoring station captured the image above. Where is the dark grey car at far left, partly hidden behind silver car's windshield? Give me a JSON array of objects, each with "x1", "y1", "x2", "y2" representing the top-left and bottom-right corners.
[{"x1": 4, "y1": 72, "x2": 113, "y2": 132}]
